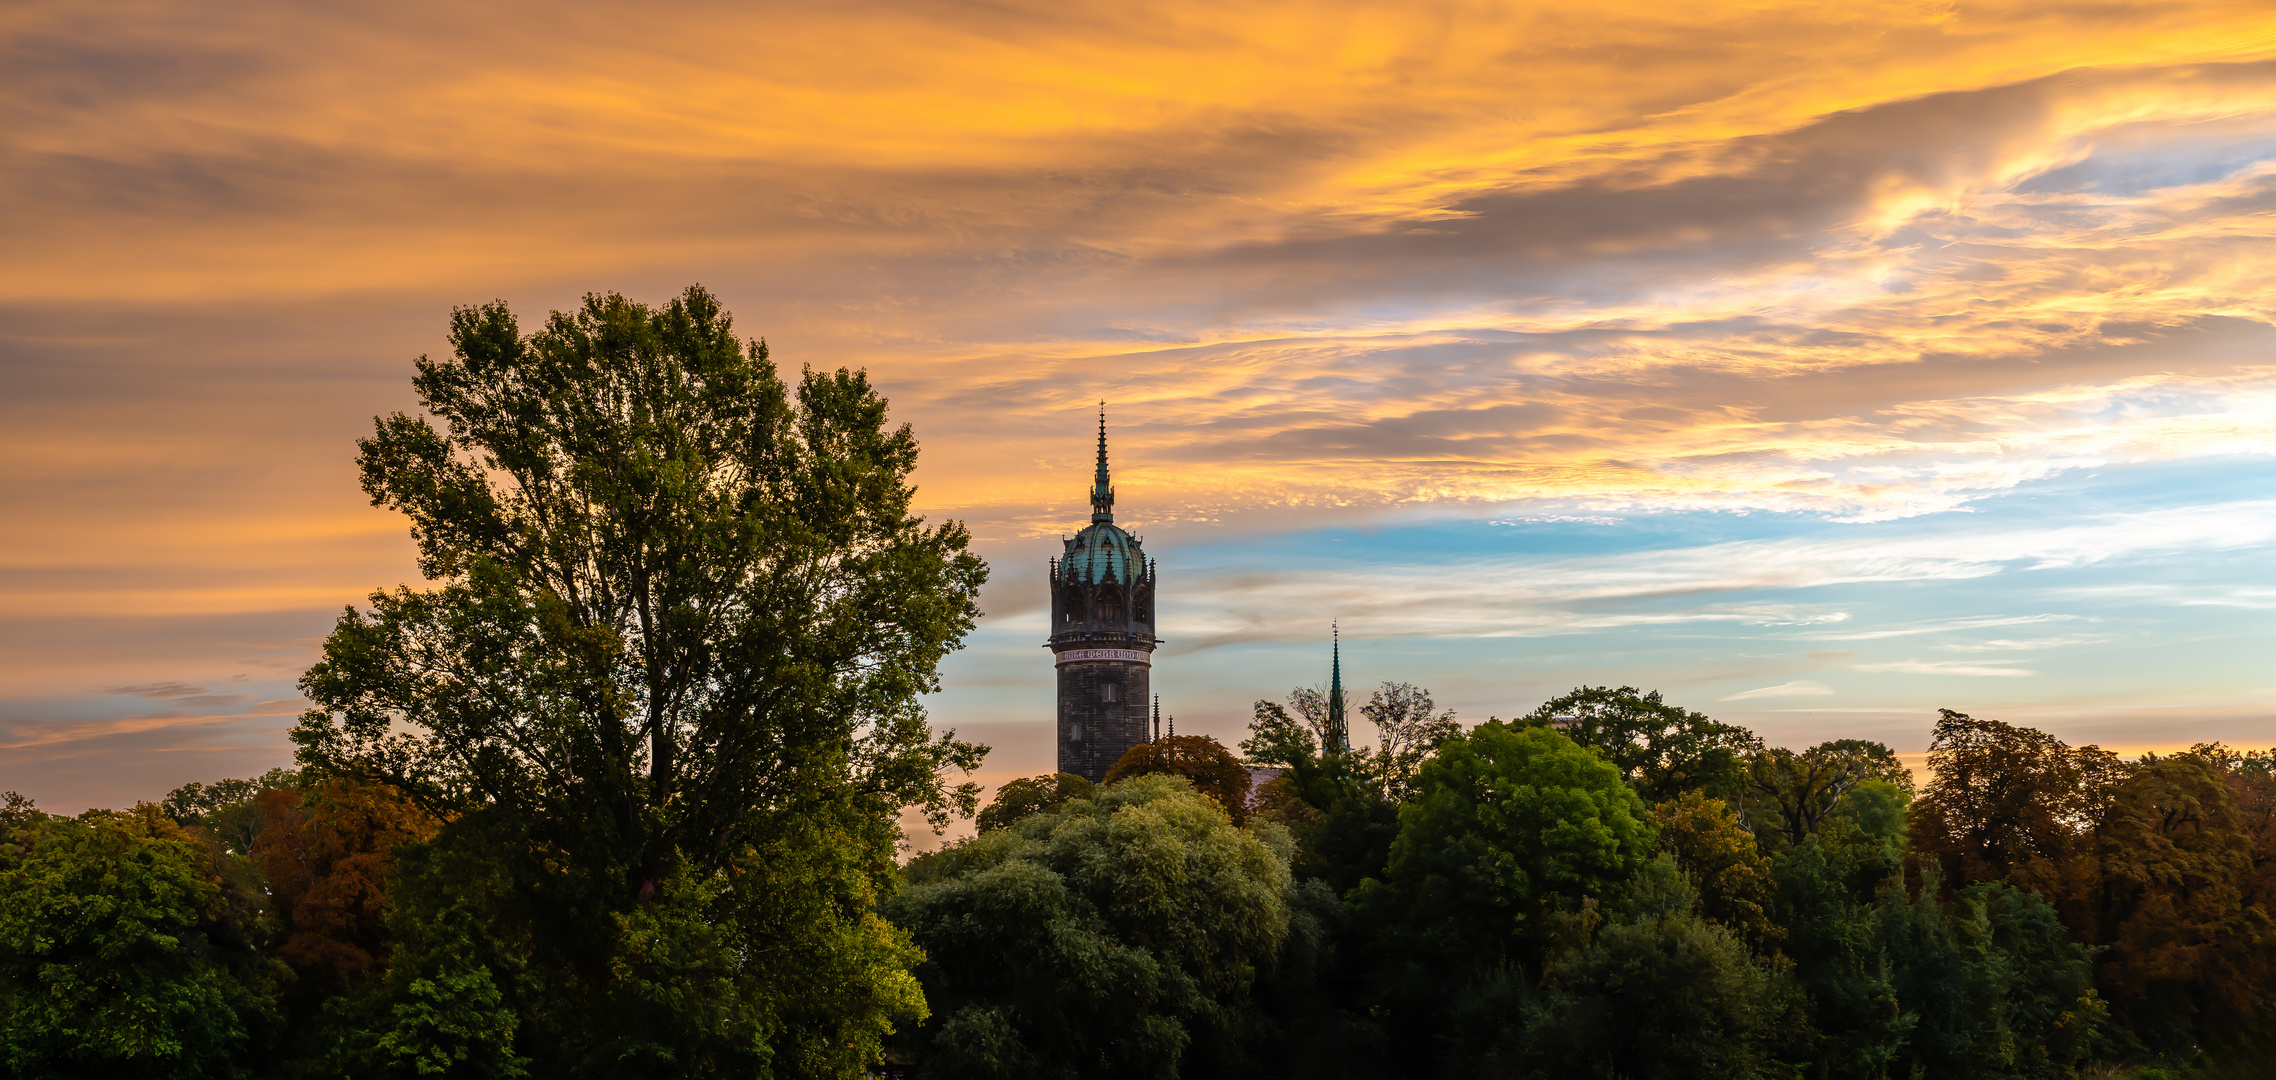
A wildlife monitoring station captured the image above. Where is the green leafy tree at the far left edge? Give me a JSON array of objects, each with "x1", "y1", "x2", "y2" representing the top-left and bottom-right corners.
[{"x1": 0, "y1": 805, "x2": 285, "y2": 1080}]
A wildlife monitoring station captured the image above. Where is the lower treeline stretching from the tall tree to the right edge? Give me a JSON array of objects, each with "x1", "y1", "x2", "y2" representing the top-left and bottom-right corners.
[{"x1": 883, "y1": 684, "x2": 2276, "y2": 1080}]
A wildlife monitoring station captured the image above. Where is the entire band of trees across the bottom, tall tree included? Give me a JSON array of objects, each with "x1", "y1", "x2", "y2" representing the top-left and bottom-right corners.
[{"x1": 0, "y1": 289, "x2": 2276, "y2": 1080}]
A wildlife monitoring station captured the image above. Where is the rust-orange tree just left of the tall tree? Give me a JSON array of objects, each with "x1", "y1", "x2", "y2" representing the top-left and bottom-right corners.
[{"x1": 253, "y1": 780, "x2": 442, "y2": 991}]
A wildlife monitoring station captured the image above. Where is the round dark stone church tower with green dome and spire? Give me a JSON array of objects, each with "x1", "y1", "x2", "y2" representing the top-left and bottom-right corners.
[{"x1": 1049, "y1": 402, "x2": 1161, "y2": 782}]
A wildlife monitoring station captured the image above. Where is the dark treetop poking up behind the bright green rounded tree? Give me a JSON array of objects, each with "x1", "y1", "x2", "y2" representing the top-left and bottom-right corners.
[{"x1": 1516, "y1": 687, "x2": 1762, "y2": 803}]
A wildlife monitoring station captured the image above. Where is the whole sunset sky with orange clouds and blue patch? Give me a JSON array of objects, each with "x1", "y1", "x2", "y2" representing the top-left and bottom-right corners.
[{"x1": 0, "y1": 0, "x2": 2276, "y2": 812}]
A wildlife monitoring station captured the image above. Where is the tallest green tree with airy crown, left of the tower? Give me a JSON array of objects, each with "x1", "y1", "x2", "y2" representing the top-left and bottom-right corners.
[{"x1": 294, "y1": 289, "x2": 986, "y2": 1075}]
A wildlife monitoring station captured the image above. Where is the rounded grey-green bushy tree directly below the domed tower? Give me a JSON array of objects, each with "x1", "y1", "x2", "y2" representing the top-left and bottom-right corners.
[{"x1": 885, "y1": 775, "x2": 1290, "y2": 1078}]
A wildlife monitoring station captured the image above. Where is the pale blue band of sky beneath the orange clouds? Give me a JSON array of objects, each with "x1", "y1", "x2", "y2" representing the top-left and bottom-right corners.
[{"x1": 933, "y1": 459, "x2": 2276, "y2": 769}]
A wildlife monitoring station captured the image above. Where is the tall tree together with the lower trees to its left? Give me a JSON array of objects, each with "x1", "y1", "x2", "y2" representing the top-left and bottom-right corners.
[{"x1": 0, "y1": 289, "x2": 986, "y2": 1078}]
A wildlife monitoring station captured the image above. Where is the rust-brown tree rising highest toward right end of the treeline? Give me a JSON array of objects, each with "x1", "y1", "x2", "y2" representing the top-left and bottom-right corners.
[{"x1": 1912, "y1": 709, "x2": 2126, "y2": 907}]
